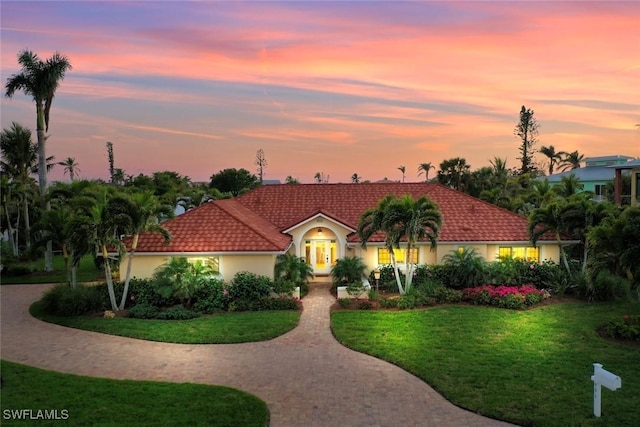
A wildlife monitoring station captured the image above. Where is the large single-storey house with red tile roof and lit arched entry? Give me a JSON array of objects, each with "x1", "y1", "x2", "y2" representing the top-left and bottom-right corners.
[{"x1": 121, "y1": 183, "x2": 559, "y2": 280}]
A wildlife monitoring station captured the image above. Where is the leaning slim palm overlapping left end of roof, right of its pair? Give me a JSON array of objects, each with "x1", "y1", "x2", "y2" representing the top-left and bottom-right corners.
[{"x1": 120, "y1": 191, "x2": 171, "y2": 310}]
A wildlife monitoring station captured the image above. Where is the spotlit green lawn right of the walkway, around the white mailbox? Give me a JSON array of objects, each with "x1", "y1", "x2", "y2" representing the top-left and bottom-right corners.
[{"x1": 331, "y1": 303, "x2": 640, "y2": 426}]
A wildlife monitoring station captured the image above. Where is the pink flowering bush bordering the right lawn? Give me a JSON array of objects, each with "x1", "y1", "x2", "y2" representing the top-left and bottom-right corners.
[{"x1": 462, "y1": 285, "x2": 545, "y2": 309}]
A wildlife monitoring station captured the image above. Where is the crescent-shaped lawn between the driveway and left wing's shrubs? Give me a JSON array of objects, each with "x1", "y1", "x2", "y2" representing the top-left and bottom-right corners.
[{"x1": 30, "y1": 302, "x2": 300, "y2": 344}]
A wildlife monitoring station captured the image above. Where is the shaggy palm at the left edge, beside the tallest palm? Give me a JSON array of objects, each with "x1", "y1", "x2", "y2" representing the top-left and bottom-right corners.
[{"x1": 0, "y1": 122, "x2": 38, "y2": 250}]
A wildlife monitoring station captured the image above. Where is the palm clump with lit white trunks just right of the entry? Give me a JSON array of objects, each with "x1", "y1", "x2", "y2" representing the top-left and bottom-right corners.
[{"x1": 357, "y1": 195, "x2": 442, "y2": 294}]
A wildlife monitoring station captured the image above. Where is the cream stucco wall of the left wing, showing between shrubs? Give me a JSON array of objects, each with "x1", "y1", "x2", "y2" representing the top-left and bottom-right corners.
[{"x1": 120, "y1": 254, "x2": 276, "y2": 281}]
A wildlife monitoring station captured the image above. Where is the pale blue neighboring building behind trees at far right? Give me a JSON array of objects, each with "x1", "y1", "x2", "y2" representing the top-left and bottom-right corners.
[{"x1": 541, "y1": 155, "x2": 633, "y2": 201}]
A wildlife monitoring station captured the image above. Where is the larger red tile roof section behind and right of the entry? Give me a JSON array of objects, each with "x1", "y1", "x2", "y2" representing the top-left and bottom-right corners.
[{"x1": 235, "y1": 182, "x2": 550, "y2": 242}]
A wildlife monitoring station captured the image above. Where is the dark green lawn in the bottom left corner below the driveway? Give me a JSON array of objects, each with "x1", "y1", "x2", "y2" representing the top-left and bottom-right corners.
[{"x1": 0, "y1": 360, "x2": 269, "y2": 426}]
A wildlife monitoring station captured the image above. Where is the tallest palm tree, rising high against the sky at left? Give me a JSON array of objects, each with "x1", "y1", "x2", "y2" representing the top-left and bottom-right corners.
[{"x1": 5, "y1": 50, "x2": 72, "y2": 271}]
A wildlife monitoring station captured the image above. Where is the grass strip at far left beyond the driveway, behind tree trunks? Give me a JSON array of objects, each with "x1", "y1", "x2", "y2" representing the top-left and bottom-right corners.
[{"x1": 0, "y1": 255, "x2": 104, "y2": 285}]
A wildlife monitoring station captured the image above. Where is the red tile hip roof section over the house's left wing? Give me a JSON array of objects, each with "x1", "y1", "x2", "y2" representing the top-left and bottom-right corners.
[{"x1": 134, "y1": 199, "x2": 291, "y2": 253}]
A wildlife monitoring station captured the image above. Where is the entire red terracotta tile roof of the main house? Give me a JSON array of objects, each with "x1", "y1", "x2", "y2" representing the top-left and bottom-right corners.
[{"x1": 132, "y1": 183, "x2": 553, "y2": 252}]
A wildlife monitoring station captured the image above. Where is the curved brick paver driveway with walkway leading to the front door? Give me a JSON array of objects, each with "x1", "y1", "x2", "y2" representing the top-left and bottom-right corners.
[{"x1": 0, "y1": 285, "x2": 508, "y2": 427}]
